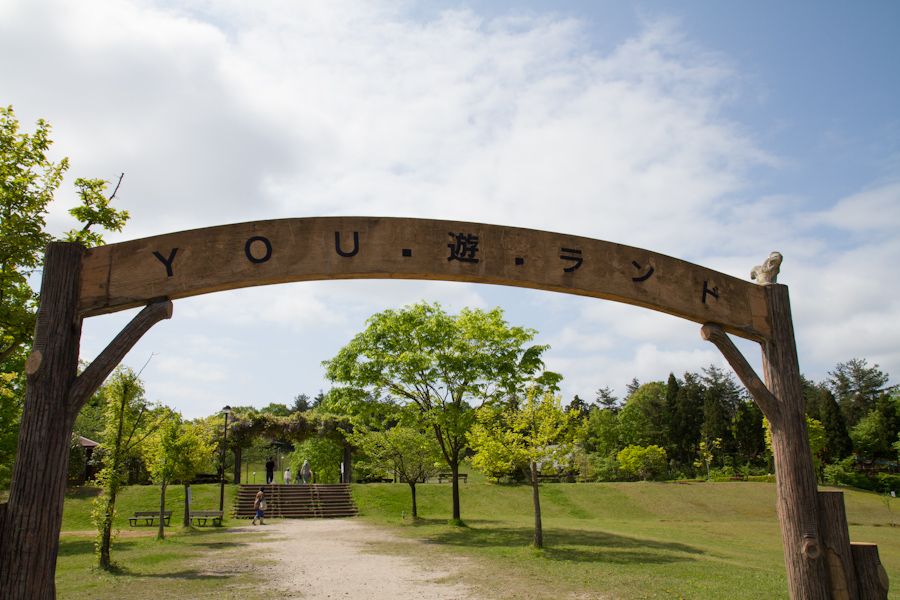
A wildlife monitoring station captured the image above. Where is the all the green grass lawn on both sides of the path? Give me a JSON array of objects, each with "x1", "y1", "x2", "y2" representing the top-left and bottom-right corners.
[{"x1": 51, "y1": 474, "x2": 900, "y2": 600}]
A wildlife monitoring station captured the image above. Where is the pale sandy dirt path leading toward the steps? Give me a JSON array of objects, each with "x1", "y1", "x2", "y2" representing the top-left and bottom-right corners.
[{"x1": 241, "y1": 519, "x2": 474, "y2": 600}]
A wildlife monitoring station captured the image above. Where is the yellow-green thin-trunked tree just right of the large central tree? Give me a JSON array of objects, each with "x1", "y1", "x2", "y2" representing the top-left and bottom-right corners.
[{"x1": 470, "y1": 388, "x2": 580, "y2": 548}]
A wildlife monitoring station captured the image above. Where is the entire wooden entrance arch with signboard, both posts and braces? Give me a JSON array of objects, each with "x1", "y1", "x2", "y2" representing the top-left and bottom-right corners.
[{"x1": 0, "y1": 217, "x2": 887, "y2": 599}]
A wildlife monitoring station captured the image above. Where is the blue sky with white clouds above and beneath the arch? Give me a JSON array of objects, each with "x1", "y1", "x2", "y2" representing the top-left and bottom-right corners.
[{"x1": 0, "y1": 0, "x2": 900, "y2": 417}]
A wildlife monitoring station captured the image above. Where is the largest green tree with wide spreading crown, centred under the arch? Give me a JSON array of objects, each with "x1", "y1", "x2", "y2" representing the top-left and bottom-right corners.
[{"x1": 324, "y1": 302, "x2": 546, "y2": 522}]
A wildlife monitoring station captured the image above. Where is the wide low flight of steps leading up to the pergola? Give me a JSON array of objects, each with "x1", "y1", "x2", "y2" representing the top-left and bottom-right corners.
[{"x1": 234, "y1": 483, "x2": 356, "y2": 519}]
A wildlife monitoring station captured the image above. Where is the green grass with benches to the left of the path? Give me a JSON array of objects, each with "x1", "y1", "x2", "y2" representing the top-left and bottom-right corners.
[{"x1": 56, "y1": 485, "x2": 260, "y2": 600}]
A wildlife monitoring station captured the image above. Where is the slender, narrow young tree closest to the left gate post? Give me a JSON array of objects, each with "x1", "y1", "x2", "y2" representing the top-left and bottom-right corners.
[{"x1": 92, "y1": 367, "x2": 161, "y2": 570}]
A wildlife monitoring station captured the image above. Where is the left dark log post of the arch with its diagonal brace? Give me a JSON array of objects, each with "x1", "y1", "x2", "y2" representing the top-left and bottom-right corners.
[{"x1": 0, "y1": 242, "x2": 172, "y2": 600}]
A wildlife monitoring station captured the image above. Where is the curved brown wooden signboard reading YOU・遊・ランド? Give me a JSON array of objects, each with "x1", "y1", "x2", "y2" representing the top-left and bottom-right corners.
[{"x1": 79, "y1": 217, "x2": 771, "y2": 340}]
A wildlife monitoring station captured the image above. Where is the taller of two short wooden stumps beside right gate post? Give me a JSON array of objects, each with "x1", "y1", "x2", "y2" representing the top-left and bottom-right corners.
[{"x1": 819, "y1": 491, "x2": 859, "y2": 600}]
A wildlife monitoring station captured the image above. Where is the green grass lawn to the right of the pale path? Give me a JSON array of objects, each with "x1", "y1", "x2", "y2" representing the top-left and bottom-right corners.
[{"x1": 354, "y1": 483, "x2": 900, "y2": 598}]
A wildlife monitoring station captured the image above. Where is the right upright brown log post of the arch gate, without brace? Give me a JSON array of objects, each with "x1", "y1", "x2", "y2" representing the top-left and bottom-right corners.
[{"x1": 762, "y1": 284, "x2": 830, "y2": 600}]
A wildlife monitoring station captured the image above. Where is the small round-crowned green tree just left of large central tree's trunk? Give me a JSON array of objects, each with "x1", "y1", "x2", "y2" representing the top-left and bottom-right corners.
[{"x1": 349, "y1": 425, "x2": 442, "y2": 519}]
